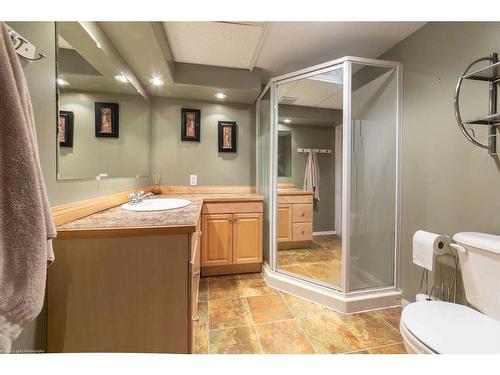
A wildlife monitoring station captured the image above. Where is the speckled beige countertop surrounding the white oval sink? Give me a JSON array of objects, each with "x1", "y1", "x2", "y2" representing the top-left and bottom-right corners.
[{"x1": 57, "y1": 193, "x2": 263, "y2": 237}]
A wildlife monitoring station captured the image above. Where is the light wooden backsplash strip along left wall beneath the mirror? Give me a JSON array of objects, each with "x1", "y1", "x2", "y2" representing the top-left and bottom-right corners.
[{"x1": 51, "y1": 186, "x2": 151, "y2": 227}]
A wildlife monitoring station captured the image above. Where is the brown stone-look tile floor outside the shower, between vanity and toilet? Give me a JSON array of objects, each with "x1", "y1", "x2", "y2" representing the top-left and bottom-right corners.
[{"x1": 194, "y1": 274, "x2": 406, "y2": 354}]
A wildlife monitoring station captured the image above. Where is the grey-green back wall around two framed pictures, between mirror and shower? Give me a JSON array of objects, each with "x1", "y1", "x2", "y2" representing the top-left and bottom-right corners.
[{"x1": 151, "y1": 97, "x2": 255, "y2": 186}]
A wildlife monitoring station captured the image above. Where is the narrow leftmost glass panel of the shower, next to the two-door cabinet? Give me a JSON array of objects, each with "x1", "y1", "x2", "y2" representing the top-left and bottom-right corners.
[{"x1": 257, "y1": 89, "x2": 272, "y2": 264}]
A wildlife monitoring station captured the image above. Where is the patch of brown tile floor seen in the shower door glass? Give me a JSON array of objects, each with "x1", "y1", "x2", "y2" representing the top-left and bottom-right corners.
[{"x1": 278, "y1": 235, "x2": 342, "y2": 286}]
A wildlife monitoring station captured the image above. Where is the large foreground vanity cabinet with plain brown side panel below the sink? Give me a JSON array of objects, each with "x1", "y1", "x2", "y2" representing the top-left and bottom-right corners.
[{"x1": 47, "y1": 228, "x2": 201, "y2": 353}]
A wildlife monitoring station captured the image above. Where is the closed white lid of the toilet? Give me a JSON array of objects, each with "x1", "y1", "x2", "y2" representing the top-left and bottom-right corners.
[{"x1": 401, "y1": 301, "x2": 500, "y2": 354}]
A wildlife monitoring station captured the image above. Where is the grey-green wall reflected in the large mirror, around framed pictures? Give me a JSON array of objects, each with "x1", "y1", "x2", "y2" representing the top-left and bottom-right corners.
[{"x1": 59, "y1": 90, "x2": 151, "y2": 179}]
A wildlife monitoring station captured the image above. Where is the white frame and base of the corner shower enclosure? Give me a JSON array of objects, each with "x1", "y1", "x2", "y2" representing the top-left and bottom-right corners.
[{"x1": 256, "y1": 56, "x2": 403, "y2": 314}]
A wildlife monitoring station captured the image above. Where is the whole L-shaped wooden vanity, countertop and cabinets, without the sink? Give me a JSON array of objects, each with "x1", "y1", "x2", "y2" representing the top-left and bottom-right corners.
[{"x1": 47, "y1": 194, "x2": 262, "y2": 353}]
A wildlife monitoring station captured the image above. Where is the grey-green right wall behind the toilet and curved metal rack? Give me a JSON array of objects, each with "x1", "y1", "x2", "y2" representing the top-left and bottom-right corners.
[{"x1": 381, "y1": 22, "x2": 500, "y2": 301}]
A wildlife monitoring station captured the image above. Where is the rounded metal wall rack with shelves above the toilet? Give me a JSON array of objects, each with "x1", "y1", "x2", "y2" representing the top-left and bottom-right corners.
[{"x1": 453, "y1": 53, "x2": 500, "y2": 155}]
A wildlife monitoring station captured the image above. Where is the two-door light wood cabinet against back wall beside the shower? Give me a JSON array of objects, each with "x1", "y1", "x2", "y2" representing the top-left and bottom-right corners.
[{"x1": 202, "y1": 202, "x2": 263, "y2": 276}]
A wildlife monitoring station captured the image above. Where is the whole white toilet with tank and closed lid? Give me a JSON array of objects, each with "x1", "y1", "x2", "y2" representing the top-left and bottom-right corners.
[{"x1": 400, "y1": 232, "x2": 500, "y2": 354}]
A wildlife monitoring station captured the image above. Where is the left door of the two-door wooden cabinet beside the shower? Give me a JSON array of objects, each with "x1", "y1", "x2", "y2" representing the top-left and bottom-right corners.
[{"x1": 201, "y1": 214, "x2": 233, "y2": 267}]
